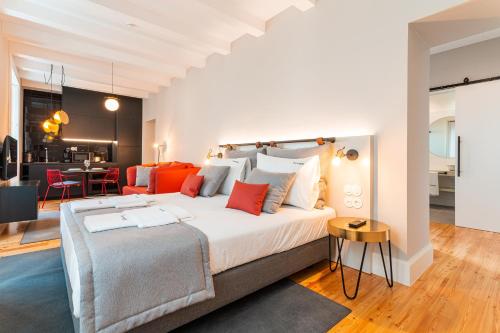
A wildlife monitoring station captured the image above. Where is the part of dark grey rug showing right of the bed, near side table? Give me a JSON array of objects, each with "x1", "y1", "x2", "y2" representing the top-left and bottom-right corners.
[{"x1": 174, "y1": 279, "x2": 351, "y2": 333}]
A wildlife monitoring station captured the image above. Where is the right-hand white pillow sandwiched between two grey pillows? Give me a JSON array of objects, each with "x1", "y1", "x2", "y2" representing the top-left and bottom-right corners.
[{"x1": 257, "y1": 154, "x2": 321, "y2": 210}]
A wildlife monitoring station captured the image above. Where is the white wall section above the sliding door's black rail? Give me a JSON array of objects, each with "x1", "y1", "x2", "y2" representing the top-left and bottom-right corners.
[{"x1": 431, "y1": 38, "x2": 500, "y2": 87}]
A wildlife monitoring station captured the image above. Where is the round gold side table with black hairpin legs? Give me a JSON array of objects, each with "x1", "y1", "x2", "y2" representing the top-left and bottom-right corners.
[{"x1": 328, "y1": 217, "x2": 394, "y2": 299}]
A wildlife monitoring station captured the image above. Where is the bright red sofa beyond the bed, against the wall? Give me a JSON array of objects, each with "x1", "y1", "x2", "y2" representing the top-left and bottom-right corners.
[{"x1": 122, "y1": 162, "x2": 200, "y2": 195}]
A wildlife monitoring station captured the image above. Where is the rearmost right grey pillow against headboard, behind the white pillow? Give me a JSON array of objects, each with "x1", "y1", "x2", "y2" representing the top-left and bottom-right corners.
[{"x1": 267, "y1": 142, "x2": 333, "y2": 209}]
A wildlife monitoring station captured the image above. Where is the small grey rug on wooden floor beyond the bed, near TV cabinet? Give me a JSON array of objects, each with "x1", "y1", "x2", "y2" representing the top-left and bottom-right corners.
[{"x1": 21, "y1": 211, "x2": 61, "y2": 244}]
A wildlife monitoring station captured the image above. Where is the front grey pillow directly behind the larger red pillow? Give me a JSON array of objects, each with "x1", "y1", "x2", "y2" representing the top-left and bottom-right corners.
[{"x1": 245, "y1": 169, "x2": 295, "y2": 214}]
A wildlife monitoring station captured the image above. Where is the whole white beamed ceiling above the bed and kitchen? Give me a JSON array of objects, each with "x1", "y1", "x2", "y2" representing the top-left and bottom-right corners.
[{"x1": 0, "y1": 0, "x2": 315, "y2": 98}]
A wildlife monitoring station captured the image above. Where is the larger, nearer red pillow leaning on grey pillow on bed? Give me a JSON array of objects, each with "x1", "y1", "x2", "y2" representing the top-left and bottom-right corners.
[{"x1": 226, "y1": 181, "x2": 269, "y2": 216}]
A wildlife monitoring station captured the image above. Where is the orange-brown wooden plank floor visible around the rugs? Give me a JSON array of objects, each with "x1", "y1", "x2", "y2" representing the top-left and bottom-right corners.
[{"x1": 0, "y1": 201, "x2": 500, "y2": 333}]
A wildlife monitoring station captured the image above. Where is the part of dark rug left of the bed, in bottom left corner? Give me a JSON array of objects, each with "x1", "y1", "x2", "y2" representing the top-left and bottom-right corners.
[{"x1": 0, "y1": 249, "x2": 73, "y2": 333}]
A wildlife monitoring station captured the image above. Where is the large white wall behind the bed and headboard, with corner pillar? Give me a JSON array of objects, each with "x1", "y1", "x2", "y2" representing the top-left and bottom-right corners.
[{"x1": 144, "y1": 0, "x2": 462, "y2": 283}]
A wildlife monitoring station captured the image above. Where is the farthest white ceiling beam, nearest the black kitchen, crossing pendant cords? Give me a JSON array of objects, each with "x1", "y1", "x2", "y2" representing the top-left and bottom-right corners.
[{"x1": 14, "y1": 57, "x2": 159, "y2": 93}]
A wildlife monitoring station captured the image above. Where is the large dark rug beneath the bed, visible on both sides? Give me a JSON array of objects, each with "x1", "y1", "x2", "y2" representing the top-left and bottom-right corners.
[{"x1": 0, "y1": 249, "x2": 351, "y2": 333}]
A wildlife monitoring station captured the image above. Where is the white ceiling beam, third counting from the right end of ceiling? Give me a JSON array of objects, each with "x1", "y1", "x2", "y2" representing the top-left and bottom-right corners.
[{"x1": 89, "y1": 0, "x2": 231, "y2": 55}]
